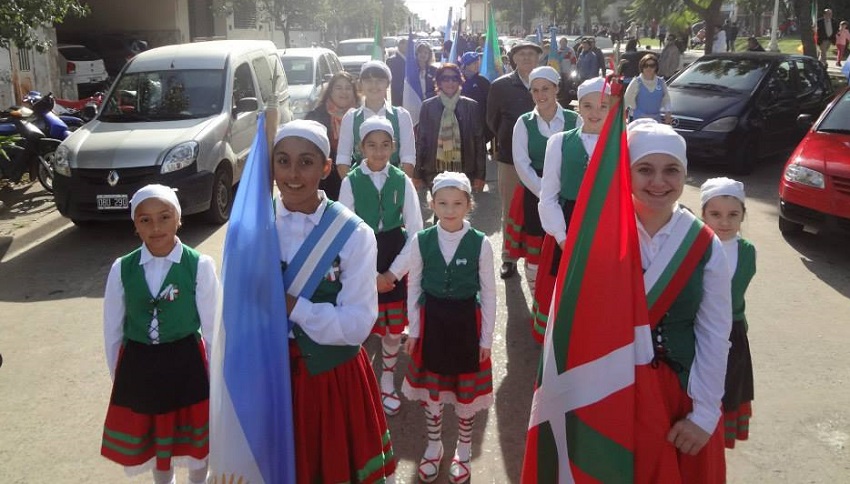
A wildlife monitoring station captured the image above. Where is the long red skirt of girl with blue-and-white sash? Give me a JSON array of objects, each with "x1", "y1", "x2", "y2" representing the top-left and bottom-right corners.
[{"x1": 289, "y1": 342, "x2": 396, "y2": 484}]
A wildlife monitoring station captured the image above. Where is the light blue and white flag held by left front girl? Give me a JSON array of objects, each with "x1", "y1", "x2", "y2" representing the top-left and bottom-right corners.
[{"x1": 209, "y1": 114, "x2": 295, "y2": 484}]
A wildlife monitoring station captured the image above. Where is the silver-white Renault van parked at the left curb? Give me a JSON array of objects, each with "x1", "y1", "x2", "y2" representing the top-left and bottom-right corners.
[{"x1": 54, "y1": 40, "x2": 292, "y2": 225}]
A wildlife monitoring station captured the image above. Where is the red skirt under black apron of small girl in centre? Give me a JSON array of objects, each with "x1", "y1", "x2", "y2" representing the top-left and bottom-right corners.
[{"x1": 402, "y1": 308, "x2": 493, "y2": 418}]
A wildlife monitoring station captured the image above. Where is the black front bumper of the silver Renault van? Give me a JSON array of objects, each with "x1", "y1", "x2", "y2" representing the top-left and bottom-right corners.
[{"x1": 53, "y1": 166, "x2": 214, "y2": 221}]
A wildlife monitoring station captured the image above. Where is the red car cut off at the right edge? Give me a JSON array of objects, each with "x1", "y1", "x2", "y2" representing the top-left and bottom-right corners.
[{"x1": 779, "y1": 87, "x2": 850, "y2": 234}]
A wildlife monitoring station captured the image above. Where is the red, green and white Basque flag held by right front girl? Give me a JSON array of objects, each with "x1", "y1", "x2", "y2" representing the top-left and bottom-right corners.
[{"x1": 522, "y1": 89, "x2": 676, "y2": 484}]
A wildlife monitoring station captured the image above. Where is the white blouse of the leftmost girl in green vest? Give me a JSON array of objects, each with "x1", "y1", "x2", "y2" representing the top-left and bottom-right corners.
[{"x1": 103, "y1": 239, "x2": 221, "y2": 379}]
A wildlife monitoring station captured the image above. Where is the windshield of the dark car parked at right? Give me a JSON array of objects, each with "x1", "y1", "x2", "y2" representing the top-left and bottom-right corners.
[{"x1": 670, "y1": 59, "x2": 769, "y2": 92}]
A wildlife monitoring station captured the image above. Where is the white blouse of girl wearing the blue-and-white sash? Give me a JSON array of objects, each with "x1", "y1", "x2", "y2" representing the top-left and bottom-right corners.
[{"x1": 274, "y1": 193, "x2": 378, "y2": 346}]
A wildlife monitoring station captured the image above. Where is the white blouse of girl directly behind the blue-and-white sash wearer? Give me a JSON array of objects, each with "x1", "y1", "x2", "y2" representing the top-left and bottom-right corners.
[{"x1": 339, "y1": 160, "x2": 424, "y2": 279}]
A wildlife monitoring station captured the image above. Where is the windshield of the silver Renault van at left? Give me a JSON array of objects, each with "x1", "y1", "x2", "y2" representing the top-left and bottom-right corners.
[{"x1": 98, "y1": 69, "x2": 224, "y2": 123}]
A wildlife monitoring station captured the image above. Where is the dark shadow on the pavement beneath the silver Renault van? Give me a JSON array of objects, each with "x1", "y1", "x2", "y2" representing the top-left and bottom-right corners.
[{"x1": 0, "y1": 217, "x2": 219, "y2": 302}]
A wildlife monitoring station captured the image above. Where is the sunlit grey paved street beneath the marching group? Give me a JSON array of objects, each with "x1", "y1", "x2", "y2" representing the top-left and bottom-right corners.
[{"x1": 0, "y1": 154, "x2": 850, "y2": 483}]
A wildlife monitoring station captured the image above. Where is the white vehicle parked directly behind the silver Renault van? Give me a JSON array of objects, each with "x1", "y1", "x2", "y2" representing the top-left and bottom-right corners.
[{"x1": 277, "y1": 47, "x2": 342, "y2": 119}]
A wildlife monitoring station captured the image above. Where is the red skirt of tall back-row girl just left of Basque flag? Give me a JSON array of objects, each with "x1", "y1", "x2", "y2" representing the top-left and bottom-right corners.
[{"x1": 505, "y1": 184, "x2": 545, "y2": 264}]
